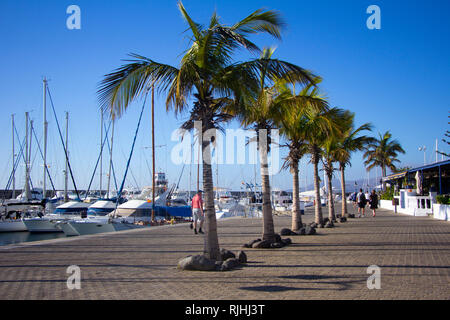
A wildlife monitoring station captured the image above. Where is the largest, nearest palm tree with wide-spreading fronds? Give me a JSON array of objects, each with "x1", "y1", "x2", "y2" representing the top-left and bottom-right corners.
[{"x1": 98, "y1": 2, "x2": 290, "y2": 260}]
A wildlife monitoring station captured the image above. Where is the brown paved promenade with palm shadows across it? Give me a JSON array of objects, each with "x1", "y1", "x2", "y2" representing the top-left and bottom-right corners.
[{"x1": 0, "y1": 205, "x2": 450, "y2": 300}]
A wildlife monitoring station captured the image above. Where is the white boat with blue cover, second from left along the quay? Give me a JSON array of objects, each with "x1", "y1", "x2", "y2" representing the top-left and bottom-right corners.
[{"x1": 24, "y1": 201, "x2": 91, "y2": 232}]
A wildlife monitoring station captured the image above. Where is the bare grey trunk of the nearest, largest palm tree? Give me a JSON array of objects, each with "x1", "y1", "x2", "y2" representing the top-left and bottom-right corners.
[{"x1": 202, "y1": 141, "x2": 220, "y2": 261}]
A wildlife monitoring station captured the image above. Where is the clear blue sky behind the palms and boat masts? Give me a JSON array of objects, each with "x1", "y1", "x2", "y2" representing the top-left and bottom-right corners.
[{"x1": 0, "y1": 0, "x2": 450, "y2": 189}]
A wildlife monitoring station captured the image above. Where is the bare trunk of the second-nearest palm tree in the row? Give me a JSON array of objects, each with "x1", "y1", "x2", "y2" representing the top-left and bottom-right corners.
[{"x1": 259, "y1": 139, "x2": 275, "y2": 242}]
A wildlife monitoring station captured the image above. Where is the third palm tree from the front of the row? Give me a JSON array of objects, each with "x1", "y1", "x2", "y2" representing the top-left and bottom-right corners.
[{"x1": 278, "y1": 79, "x2": 328, "y2": 231}]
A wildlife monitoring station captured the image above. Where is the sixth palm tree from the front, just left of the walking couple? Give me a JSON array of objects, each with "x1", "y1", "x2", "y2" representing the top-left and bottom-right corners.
[{"x1": 334, "y1": 113, "x2": 374, "y2": 217}]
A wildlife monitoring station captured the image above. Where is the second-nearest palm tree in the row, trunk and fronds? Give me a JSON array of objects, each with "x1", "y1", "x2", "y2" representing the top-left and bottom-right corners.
[{"x1": 232, "y1": 48, "x2": 316, "y2": 242}]
